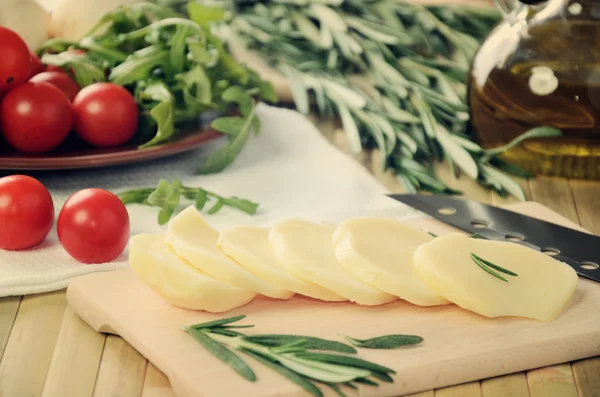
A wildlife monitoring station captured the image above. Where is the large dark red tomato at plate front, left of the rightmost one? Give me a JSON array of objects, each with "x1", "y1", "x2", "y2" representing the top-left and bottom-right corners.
[{"x1": 1, "y1": 82, "x2": 73, "y2": 153}]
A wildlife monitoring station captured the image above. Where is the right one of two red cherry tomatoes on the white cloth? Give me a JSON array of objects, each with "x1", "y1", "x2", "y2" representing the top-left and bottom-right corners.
[{"x1": 57, "y1": 189, "x2": 129, "y2": 263}]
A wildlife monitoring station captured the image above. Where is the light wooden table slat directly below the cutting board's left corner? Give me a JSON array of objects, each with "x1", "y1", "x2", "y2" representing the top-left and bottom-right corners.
[{"x1": 42, "y1": 307, "x2": 105, "y2": 397}]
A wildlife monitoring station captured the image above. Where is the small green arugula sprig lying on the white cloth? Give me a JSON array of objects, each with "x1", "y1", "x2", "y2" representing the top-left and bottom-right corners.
[{"x1": 118, "y1": 179, "x2": 258, "y2": 225}]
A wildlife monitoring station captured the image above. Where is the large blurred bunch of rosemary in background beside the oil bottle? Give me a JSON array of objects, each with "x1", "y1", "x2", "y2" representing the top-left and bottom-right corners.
[{"x1": 221, "y1": 0, "x2": 560, "y2": 199}]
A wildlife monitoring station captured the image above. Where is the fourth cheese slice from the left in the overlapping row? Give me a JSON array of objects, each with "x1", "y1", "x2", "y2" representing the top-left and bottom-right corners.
[{"x1": 269, "y1": 219, "x2": 397, "y2": 305}]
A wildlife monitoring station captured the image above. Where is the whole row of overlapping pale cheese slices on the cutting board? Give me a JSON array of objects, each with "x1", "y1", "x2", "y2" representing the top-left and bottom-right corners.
[{"x1": 129, "y1": 207, "x2": 577, "y2": 321}]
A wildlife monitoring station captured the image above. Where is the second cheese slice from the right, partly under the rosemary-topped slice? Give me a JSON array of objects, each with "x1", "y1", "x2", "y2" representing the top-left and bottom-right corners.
[{"x1": 333, "y1": 217, "x2": 450, "y2": 306}]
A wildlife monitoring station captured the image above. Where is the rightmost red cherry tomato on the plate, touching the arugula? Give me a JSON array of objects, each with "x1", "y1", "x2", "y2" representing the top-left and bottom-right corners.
[{"x1": 73, "y1": 83, "x2": 138, "y2": 147}]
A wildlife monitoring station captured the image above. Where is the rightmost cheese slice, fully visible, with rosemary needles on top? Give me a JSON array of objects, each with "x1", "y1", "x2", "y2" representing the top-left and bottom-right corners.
[{"x1": 415, "y1": 233, "x2": 577, "y2": 321}]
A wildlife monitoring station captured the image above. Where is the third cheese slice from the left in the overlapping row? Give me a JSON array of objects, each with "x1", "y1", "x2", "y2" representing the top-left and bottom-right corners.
[{"x1": 217, "y1": 226, "x2": 346, "y2": 301}]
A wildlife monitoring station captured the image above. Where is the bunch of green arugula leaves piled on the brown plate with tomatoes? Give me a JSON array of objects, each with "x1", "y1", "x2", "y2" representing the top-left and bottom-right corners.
[{"x1": 40, "y1": 1, "x2": 277, "y2": 174}]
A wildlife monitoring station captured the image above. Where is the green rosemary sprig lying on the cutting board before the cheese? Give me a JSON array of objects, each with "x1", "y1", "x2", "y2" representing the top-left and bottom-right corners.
[{"x1": 184, "y1": 315, "x2": 422, "y2": 397}]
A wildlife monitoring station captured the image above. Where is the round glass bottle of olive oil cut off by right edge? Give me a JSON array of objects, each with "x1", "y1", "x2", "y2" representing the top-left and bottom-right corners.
[{"x1": 469, "y1": 0, "x2": 600, "y2": 179}]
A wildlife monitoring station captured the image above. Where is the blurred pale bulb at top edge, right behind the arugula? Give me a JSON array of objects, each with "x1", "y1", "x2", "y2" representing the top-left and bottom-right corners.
[{"x1": 50, "y1": 0, "x2": 139, "y2": 41}]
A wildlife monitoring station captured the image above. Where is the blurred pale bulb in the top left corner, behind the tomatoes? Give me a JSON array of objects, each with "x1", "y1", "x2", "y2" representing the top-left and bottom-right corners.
[{"x1": 0, "y1": 0, "x2": 50, "y2": 50}]
